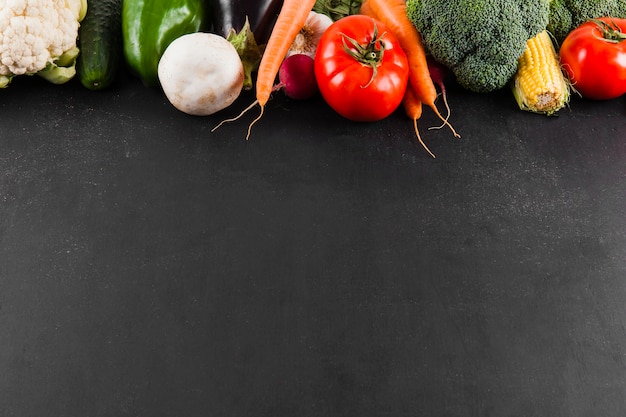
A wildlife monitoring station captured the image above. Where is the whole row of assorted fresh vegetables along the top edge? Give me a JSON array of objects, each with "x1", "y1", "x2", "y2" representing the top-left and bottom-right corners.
[{"x1": 0, "y1": 0, "x2": 626, "y2": 157}]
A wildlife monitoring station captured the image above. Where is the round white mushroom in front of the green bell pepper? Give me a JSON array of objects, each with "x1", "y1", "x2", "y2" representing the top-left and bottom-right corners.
[{"x1": 158, "y1": 32, "x2": 244, "y2": 116}]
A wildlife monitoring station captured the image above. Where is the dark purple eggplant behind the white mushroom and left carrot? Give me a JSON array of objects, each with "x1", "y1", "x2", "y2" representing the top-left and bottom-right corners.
[{"x1": 210, "y1": 0, "x2": 283, "y2": 45}]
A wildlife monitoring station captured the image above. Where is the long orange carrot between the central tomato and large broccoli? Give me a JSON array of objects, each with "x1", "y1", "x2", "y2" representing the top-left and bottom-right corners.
[{"x1": 361, "y1": 0, "x2": 460, "y2": 137}]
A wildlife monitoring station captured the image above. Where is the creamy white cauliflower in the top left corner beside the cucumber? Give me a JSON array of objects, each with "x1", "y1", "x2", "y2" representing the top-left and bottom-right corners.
[{"x1": 0, "y1": 0, "x2": 87, "y2": 87}]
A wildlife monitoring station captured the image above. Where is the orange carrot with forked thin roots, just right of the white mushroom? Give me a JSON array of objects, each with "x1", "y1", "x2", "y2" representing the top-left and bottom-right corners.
[{"x1": 212, "y1": 0, "x2": 315, "y2": 140}]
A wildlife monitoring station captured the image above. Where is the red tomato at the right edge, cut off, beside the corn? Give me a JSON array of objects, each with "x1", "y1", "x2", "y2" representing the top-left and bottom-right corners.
[{"x1": 559, "y1": 18, "x2": 626, "y2": 100}]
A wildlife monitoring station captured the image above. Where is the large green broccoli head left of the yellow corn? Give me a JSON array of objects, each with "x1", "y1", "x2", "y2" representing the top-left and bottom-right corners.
[{"x1": 406, "y1": 0, "x2": 549, "y2": 93}]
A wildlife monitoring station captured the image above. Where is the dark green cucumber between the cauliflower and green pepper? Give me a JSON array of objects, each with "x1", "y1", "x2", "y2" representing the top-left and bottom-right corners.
[{"x1": 76, "y1": 0, "x2": 123, "y2": 90}]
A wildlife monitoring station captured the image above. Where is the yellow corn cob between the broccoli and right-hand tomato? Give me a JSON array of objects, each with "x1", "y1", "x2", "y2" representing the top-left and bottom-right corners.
[{"x1": 513, "y1": 30, "x2": 570, "y2": 115}]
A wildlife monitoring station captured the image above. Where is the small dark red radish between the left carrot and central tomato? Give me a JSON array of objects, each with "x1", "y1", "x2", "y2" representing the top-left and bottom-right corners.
[{"x1": 274, "y1": 54, "x2": 318, "y2": 100}]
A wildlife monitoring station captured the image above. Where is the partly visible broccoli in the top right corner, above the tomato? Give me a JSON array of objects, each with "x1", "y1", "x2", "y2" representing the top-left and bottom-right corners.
[{"x1": 547, "y1": 0, "x2": 626, "y2": 43}]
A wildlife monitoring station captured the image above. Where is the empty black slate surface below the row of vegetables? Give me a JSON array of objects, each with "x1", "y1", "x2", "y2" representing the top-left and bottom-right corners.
[{"x1": 0, "y1": 78, "x2": 626, "y2": 417}]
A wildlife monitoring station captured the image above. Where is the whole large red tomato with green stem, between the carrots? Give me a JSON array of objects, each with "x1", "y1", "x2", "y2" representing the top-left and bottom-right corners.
[{"x1": 315, "y1": 15, "x2": 409, "y2": 122}]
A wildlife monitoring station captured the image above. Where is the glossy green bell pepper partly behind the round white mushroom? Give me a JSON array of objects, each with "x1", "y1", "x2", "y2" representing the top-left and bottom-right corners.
[{"x1": 122, "y1": 0, "x2": 210, "y2": 86}]
